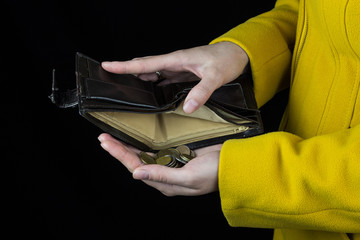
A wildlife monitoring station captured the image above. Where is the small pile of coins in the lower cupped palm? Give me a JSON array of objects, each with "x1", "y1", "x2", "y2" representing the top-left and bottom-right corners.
[{"x1": 140, "y1": 145, "x2": 195, "y2": 168}]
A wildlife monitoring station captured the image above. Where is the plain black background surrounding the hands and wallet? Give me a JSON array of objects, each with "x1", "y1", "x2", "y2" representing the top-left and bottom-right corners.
[{"x1": 7, "y1": 0, "x2": 286, "y2": 239}]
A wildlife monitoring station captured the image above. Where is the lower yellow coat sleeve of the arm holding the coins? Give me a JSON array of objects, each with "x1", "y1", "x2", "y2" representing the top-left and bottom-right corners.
[{"x1": 219, "y1": 125, "x2": 360, "y2": 232}]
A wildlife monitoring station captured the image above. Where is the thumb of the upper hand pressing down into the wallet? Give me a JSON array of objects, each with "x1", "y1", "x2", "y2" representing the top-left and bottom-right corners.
[{"x1": 183, "y1": 79, "x2": 218, "y2": 114}]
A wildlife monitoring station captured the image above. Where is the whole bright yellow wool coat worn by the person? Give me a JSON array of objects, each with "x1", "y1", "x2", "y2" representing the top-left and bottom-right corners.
[{"x1": 212, "y1": 0, "x2": 360, "y2": 240}]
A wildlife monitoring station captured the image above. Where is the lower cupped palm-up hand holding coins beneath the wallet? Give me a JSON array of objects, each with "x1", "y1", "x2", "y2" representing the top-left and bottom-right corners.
[{"x1": 99, "y1": 133, "x2": 222, "y2": 196}]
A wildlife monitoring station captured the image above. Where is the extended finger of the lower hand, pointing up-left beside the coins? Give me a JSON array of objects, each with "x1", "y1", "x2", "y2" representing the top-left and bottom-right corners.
[{"x1": 101, "y1": 140, "x2": 143, "y2": 172}]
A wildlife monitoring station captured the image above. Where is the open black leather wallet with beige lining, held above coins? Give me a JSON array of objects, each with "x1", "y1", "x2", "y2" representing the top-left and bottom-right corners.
[{"x1": 50, "y1": 53, "x2": 263, "y2": 152}]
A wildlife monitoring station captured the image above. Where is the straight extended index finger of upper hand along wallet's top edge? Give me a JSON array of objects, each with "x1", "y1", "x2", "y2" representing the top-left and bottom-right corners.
[{"x1": 101, "y1": 53, "x2": 182, "y2": 74}]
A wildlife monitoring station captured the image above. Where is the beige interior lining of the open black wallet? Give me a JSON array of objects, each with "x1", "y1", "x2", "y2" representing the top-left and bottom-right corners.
[{"x1": 89, "y1": 102, "x2": 249, "y2": 150}]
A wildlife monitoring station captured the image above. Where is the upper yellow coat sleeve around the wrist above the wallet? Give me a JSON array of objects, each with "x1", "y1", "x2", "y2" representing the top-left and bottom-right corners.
[{"x1": 211, "y1": 0, "x2": 299, "y2": 107}]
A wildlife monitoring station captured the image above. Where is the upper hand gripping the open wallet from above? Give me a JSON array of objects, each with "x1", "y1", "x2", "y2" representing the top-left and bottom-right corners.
[{"x1": 102, "y1": 42, "x2": 249, "y2": 113}]
